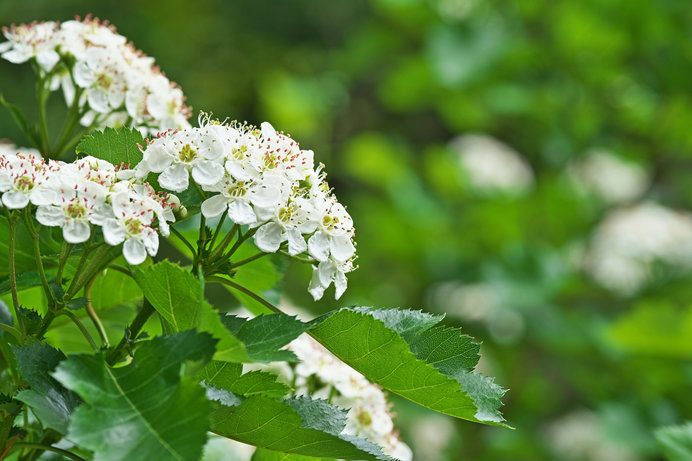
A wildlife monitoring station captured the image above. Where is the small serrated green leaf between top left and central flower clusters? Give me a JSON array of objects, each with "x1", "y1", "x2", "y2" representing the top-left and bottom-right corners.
[{"x1": 76, "y1": 127, "x2": 145, "y2": 167}]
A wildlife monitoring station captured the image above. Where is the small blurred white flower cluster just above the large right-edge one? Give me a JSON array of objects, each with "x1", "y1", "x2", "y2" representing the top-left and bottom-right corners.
[{"x1": 569, "y1": 149, "x2": 649, "y2": 204}]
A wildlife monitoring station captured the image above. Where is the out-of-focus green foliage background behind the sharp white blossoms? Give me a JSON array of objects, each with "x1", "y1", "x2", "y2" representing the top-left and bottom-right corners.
[{"x1": 0, "y1": 0, "x2": 692, "y2": 461}]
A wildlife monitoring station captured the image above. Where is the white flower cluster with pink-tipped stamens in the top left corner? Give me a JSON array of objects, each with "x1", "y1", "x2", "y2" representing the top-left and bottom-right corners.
[{"x1": 0, "y1": 16, "x2": 190, "y2": 133}]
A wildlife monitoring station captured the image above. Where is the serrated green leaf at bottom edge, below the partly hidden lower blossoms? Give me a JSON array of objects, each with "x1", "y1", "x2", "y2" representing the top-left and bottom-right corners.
[{"x1": 211, "y1": 396, "x2": 391, "y2": 460}]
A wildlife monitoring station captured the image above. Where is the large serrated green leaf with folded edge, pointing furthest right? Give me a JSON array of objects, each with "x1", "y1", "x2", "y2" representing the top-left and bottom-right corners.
[{"x1": 311, "y1": 308, "x2": 506, "y2": 426}]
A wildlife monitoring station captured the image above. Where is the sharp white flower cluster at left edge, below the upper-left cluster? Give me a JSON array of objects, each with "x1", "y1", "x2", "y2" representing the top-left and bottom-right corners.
[{"x1": 0, "y1": 147, "x2": 179, "y2": 264}]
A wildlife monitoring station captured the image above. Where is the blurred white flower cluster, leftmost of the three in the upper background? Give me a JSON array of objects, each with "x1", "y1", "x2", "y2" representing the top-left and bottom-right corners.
[{"x1": 450, "y1": 134, "x2": 533, "y2": 194}]
